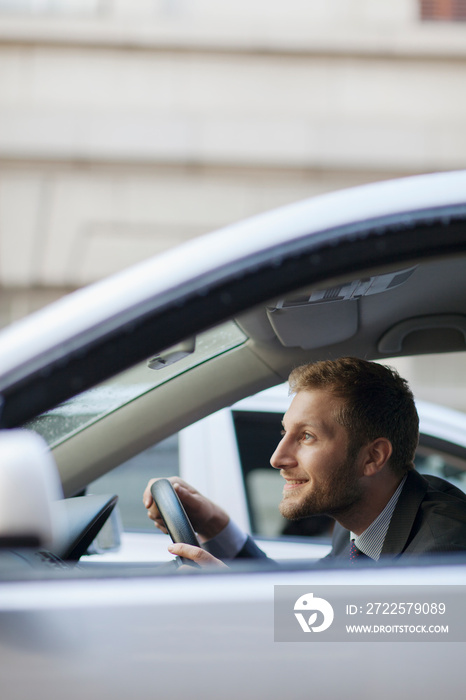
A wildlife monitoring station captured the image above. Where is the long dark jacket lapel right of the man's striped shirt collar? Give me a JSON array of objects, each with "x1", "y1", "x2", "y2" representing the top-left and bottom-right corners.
[{"x1": 382, "y1": 470, "x2": 429, "y2": 557}]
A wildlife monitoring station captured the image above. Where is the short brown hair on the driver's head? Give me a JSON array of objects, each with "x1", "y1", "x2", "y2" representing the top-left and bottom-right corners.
[{"x1": 289, "y1": 357, "x2": 419, "y2": 474}]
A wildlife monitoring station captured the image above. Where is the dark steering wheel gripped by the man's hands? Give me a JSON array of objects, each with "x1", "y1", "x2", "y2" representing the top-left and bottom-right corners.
[{"x1": 150, "y1": 479, "x2": 201, "y2": 566}]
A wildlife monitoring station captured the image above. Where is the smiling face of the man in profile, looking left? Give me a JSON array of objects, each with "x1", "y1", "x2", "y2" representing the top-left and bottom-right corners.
[{"x1": 270, "y1": 389, "x2": 363, "y2": 520}]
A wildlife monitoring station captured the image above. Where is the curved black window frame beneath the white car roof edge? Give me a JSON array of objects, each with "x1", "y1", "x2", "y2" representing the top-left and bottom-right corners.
[{"x1": 0, "y1": 204, "x2": 466, "y2": 428}]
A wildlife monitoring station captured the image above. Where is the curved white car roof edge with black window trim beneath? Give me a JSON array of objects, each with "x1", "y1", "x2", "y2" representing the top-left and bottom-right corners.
[{"x1": 0, "y1": 171, "x2": 466, "y2": 427}]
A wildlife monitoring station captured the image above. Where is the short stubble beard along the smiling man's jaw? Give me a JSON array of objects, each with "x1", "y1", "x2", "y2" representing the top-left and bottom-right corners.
[{"x1": 279, "y1": 456, "x2": 363, "y2": 520}]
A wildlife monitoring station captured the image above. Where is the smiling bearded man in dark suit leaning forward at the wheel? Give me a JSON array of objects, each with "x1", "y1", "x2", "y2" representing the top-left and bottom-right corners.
[{"x1": 143, "y1": 357, "x2": 466, "y2": 565}]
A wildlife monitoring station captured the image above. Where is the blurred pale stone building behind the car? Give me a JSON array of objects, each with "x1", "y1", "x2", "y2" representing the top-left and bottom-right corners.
[{"x1": 0, "y1": 0, "x2": 466, "y2": 408}]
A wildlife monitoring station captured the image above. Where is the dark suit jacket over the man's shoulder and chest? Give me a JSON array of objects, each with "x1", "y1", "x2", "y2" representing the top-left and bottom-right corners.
[{"x1": 329, "y1": 470, "x2": 466, "y2": 558}]
